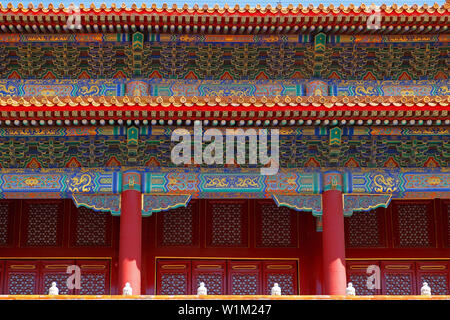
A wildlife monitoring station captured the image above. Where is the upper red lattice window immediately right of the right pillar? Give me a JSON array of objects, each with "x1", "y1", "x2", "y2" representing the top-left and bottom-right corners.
[{"x1": 345, "y1": 208, "x2": 386, "y2": 248}]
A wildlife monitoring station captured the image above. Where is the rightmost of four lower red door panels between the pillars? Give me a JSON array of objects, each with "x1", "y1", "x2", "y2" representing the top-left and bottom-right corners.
[{"x1": 262, "y1": 261, "x2": 298, "y2": 295}]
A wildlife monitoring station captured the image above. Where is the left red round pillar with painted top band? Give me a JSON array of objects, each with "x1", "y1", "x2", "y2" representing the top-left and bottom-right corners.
[{"x1": 118, "y1": 172, "x2": 142, "y2": 295}]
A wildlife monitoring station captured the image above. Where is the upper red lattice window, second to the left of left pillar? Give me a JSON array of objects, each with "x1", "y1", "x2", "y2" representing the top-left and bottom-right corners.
[{"x1": 27, "y1": 203, "x2": 61, "y2": 246}]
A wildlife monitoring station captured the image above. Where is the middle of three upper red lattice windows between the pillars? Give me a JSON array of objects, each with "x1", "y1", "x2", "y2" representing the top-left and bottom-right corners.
[{"x1": 210, "y1": 202, "x2": 245, "y2": 246}]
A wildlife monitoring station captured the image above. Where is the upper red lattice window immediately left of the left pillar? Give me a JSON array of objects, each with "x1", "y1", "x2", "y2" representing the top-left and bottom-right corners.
[{"x1": 70, "y1": 207, "x2": 112, "y2": 247}]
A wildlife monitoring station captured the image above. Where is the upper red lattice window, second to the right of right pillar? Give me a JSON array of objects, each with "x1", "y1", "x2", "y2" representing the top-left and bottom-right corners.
[{"x1": 397, "y1": 204, "x2": 433, "y2": 247}]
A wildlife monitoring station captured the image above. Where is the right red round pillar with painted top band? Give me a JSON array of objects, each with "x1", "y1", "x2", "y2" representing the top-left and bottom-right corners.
[{"x1": 322, "y1": 172, "x2": 347, "y2": 295}]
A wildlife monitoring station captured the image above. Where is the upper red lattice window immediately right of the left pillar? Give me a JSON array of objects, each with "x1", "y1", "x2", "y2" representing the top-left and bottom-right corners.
[{"x1": 162, "y1": 206, "x2": 194, "y2": 246}]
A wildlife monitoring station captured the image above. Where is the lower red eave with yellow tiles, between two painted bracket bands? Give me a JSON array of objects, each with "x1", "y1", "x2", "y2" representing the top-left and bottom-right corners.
[{"x1": 0, "y1": 96, "x2": 450, "y2": 125}]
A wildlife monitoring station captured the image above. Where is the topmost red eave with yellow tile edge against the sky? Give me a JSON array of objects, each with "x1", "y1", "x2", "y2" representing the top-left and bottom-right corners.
[{"x1": 0, "y1": 3, "x2": 450, "y2": 34}]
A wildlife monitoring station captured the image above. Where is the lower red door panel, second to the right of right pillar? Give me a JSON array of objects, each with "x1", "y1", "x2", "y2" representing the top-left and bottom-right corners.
[{"x1": 381, "y1": 261, "x2": 416, "y2": 295}]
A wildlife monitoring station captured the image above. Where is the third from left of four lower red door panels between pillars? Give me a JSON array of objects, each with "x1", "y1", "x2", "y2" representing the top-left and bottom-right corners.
[{"x1": 228, "y1": 261, "x2": 261, "y2": 295}]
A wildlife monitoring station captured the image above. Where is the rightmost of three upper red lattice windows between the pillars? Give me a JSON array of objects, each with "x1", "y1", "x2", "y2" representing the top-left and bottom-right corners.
[{"x1": 255, "y1": 201, "x2": 298, "y2": 247}]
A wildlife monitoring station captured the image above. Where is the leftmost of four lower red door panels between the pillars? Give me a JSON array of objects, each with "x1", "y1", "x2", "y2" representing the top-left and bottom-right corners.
[{"x1": 156, "y1": 260, "x2": 191, "y2": 295}]
